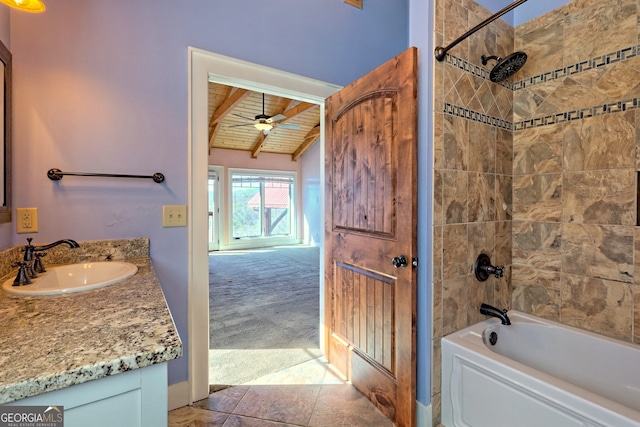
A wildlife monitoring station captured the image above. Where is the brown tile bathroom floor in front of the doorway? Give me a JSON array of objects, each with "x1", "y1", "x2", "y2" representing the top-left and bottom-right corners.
[{"x1": 169, "y1": 358, "x2": 393, "y2": 427}]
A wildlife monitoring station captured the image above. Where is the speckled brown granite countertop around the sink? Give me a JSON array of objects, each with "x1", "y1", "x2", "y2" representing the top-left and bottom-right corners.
[{"x1": 0, "y1": 258, "x2": 182, "y2": 404}]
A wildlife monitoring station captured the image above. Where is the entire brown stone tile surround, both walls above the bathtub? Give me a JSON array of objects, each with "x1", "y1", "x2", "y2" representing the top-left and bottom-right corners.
[{"x1": 431, "y1": 0, "x2": 640, "y2": 425}]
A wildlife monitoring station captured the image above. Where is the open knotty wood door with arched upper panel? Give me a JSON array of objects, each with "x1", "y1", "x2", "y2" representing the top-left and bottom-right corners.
[{"x1": 325, "y1": 48, "x2": 417, "y2": 426}]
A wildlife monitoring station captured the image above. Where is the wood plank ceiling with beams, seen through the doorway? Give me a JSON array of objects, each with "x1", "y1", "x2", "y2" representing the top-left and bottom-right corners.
[{"x1": 209, "y1": 82, "x2": 320, "y2": 161}]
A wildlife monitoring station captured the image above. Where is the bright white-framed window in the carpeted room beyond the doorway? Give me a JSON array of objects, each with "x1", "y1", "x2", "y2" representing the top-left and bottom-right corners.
[{"x1": 231, "y1": 171, "x2": 295, "y2": 239}]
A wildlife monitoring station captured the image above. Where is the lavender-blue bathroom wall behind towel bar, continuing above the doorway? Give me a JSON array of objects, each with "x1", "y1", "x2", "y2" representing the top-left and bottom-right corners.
[{"x1": 8, "y1": 0, "x2": 410, "y2": 384}]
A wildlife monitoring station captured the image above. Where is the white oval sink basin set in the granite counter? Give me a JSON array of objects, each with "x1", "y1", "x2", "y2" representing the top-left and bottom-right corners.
[{"x1": 2, "y1": 261, "x2": 138, "y2": 296}]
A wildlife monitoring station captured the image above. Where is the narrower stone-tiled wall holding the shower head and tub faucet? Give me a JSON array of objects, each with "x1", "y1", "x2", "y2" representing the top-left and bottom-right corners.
[{"x1": 431, "y1": 0, "x2": 514, "y2": 425}]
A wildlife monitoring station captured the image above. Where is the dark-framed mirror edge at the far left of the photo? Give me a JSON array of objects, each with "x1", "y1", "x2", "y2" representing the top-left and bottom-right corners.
[{"x1": 0, "y1": 37, "x2": 13, "y2": 223}]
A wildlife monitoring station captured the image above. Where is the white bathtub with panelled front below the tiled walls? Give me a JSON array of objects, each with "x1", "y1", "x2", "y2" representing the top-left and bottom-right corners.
[{"x1": 442, "y1": 311, "x2": 640, "y2": 427}]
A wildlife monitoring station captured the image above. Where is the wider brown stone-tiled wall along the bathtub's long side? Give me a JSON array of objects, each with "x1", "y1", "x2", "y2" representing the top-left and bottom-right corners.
[{"x1": 512, "y1": 0, "x2": 640, "y2": 343}]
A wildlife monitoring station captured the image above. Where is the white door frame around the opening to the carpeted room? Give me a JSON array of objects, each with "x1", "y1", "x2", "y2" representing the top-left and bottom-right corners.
[{"x1": 187, "y1": 47, "x2": 341, "y2": 404}]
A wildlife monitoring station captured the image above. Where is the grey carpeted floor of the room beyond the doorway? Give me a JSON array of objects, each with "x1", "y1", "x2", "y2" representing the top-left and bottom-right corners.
[{"x1": 209, "y1": 245, "x2": 322, "y2": 386}]
